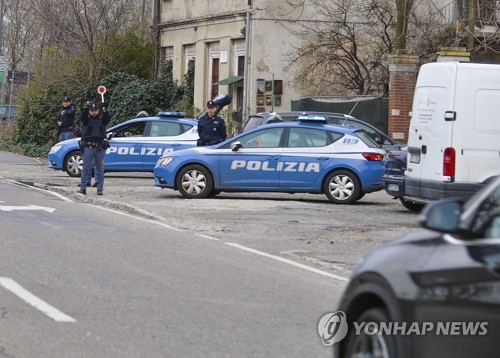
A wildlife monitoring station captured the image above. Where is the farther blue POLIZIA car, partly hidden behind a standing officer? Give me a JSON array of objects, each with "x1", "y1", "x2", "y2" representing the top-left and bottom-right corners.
[{"x1": 48, "y1": 112, "x2": 198, "y2": 177}]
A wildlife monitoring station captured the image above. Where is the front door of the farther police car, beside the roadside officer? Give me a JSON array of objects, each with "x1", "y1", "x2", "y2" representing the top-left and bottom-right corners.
[{"x1": 104, "y1": 121, "x2": 147, "y2": 171}]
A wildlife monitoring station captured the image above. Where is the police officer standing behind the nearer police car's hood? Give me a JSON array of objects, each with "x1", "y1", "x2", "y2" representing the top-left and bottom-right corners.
[{"x1": 198, "y1": 101, "x2": 227, "y2": 146}]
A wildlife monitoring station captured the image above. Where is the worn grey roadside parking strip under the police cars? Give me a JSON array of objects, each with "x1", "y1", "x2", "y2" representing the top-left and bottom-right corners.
[{"x1": 0, "y1": 152, "x2": 419, "y2": 279}]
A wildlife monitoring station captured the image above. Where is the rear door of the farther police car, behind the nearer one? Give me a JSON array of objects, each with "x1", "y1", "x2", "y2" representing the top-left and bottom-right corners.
[{"x1": 142, "y1": 120, "x2": 197, "y2": 171}]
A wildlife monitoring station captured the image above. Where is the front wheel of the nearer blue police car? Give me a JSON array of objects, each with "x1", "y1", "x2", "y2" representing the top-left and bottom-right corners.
[{"x1": 176, "y1": 165, "x2": 213, "y2": 199}]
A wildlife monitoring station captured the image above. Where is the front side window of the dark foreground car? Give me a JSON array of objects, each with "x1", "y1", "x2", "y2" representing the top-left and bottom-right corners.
[{"x1": 471, "y1": 187, "x2": 500, "y2": 238}]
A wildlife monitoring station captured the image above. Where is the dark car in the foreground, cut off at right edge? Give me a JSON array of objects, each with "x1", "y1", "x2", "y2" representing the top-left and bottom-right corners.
[{"x1": 334, "y1": 178, "x2": 500, "y2": 358}]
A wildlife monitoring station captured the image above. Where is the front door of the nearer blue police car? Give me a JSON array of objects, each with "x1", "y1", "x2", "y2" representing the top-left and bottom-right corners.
[{"x1": 219, "y1": 127, "x2": 284, "y2": 189}]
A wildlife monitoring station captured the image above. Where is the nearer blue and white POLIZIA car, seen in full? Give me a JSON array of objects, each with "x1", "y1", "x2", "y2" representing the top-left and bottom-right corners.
[{"x1": 154, "y1": 116, "x2": 386, "y2": 204}]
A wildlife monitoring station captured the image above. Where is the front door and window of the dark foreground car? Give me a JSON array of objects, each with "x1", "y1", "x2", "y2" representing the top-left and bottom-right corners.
[{"x1": 412, "y1": 186, "x2": 500, "y2": 358}]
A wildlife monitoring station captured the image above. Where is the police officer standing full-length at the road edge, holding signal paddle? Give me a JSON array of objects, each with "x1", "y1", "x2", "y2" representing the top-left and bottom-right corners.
[{"x1": 78, "y1": 102, "x2": 110, "y2": 195}]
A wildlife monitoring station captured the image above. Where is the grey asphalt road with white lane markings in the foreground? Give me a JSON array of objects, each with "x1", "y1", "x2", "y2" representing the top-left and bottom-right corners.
[{"x1": 0, "y1": 179, "x2": 343, "y2": 358}]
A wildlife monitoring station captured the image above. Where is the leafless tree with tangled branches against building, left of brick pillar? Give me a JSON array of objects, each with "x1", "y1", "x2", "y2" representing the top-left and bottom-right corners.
[{"x1": 287, "y1": 0, "x2": 395, "y2": 95}]
